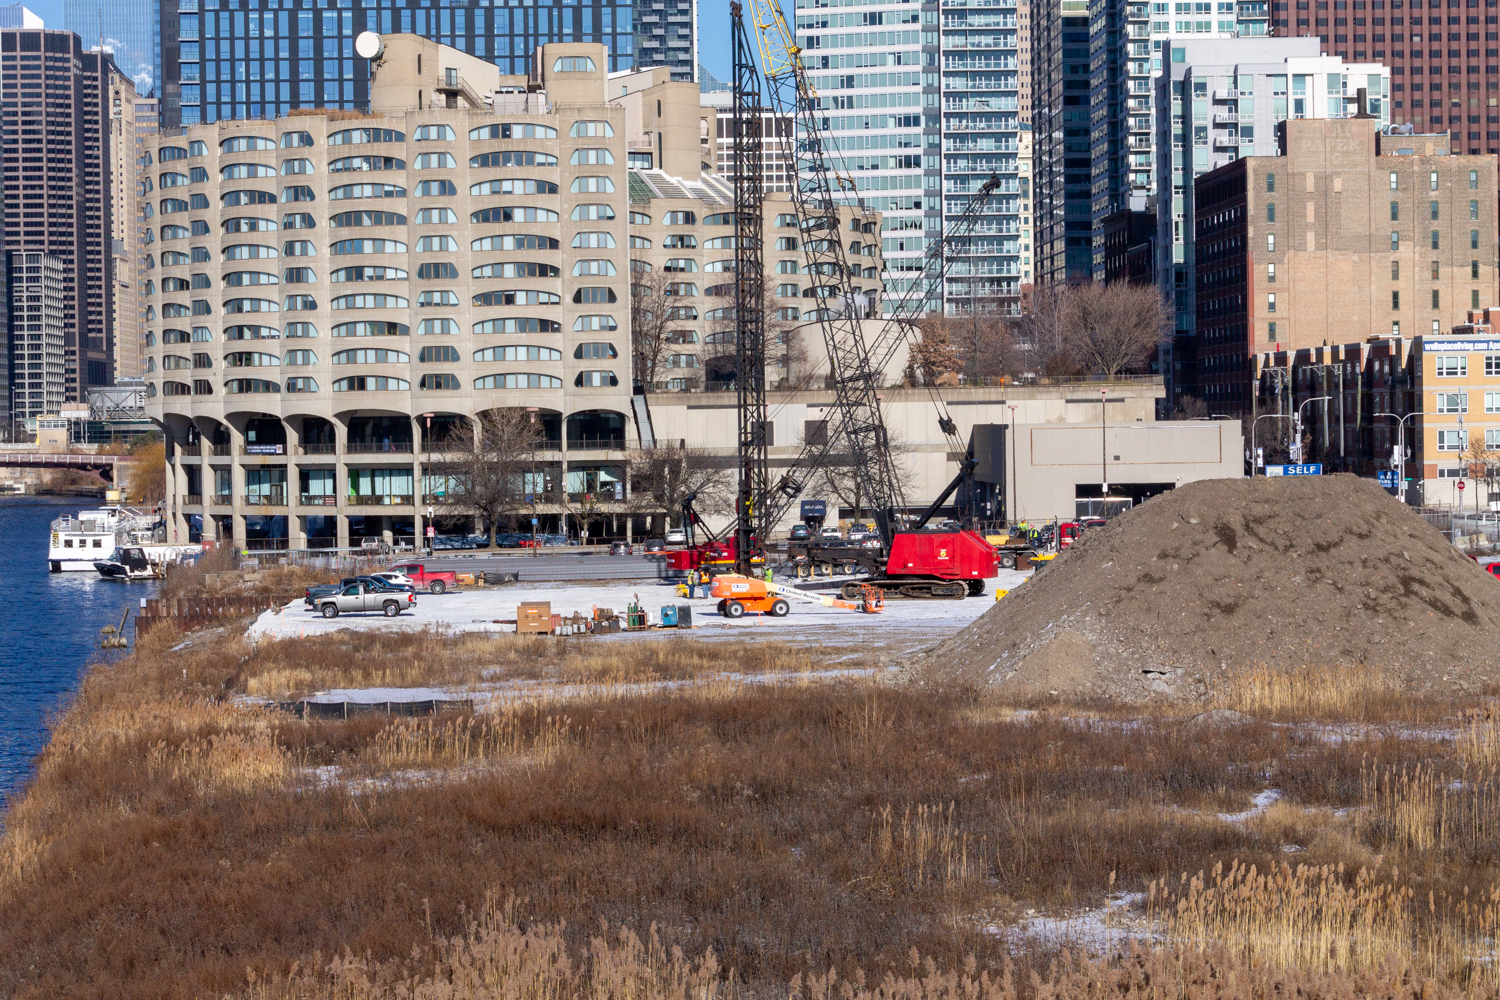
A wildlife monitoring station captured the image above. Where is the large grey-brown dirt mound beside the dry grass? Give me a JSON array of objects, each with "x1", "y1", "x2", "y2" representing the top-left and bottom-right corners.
[{"x1": 915, "y1": 475, "x2": 1500, "y2": 700}]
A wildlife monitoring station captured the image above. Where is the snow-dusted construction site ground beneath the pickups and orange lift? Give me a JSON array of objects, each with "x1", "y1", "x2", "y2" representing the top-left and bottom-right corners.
[{"x1": 248, "y1": 570, "x2": 1031, "y2": 658}]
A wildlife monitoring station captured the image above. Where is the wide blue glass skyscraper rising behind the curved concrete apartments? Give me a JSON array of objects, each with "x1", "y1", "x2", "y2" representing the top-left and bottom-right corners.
[{"x1": 158, "y1": 0, "x2": 642, "y2": 126}]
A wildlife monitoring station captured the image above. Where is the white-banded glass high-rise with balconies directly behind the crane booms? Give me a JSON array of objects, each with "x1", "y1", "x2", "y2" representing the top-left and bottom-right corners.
[{"x1": 797, "y1": 0, "x2": 1023, "y2": 313}]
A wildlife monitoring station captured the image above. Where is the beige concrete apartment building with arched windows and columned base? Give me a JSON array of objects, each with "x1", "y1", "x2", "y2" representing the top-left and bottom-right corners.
[{"x1": 141, "y1": 36, "x2": 879, "y2": 549}]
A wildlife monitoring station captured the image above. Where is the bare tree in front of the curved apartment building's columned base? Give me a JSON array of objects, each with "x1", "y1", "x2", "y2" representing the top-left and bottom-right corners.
[{"x1": 434, "y1": 408, "x2": 542, "y2": 546}]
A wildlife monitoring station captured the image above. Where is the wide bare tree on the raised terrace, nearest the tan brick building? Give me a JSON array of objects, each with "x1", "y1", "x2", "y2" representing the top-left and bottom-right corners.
[{"x1": 1064, "y1": 282, "x2": 1170, "y2": 376}]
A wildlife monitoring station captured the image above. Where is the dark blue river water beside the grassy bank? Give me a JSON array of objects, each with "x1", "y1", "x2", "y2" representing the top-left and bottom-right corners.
[{"x1": 0, "y1": 496, "x2": 156, "y2": 809}]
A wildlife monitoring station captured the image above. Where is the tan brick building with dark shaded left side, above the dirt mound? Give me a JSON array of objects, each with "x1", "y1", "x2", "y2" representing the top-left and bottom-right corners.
[{"x1": 1179, "y1": 118, "x2": 1496, "y2": 414}]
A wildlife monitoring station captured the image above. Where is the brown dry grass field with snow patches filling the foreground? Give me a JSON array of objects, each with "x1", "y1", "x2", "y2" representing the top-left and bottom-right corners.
[{"x1": 0, "y1": 611, "x2": 1500, "y2": 1000}]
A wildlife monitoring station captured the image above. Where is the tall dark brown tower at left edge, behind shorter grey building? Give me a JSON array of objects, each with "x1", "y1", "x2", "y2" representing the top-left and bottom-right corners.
[{"x1": 0, "y1": 28, "x2": 122, "y2": 402}]
